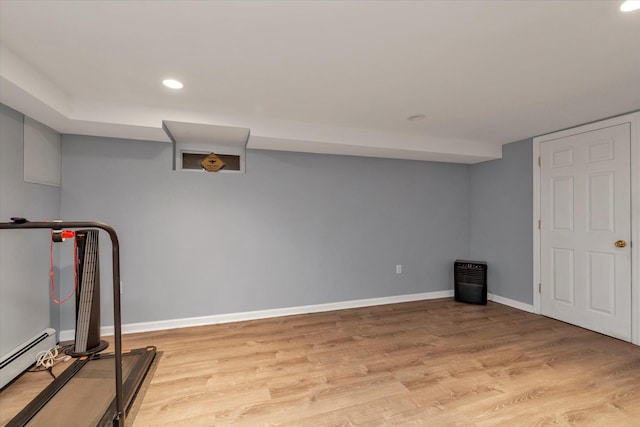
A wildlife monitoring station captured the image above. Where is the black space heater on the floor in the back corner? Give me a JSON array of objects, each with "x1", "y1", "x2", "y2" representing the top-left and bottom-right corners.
[{"x1": 453, "y1": 259, "x2": 487, "y2": 305}]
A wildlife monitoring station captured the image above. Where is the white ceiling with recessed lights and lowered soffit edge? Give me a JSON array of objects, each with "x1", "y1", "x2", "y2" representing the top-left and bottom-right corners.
[{"x1": 0, "y1": 0, "x2": 640, "y2": 163}]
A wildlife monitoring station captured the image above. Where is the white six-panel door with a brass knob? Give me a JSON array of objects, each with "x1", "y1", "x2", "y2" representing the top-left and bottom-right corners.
[{"x1": 540, "y1": 123, "x2": 632, "y2": 341}]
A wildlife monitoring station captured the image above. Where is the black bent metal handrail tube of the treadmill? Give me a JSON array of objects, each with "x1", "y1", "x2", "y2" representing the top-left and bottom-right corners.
[{"x1": 0, "y1": 221, "x2": 126, "y2": 427}]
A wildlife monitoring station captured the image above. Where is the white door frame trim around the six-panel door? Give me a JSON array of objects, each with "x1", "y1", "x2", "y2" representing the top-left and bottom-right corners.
[{"x1": 532, "y1": 112, "x2": 640, "y2": 345}]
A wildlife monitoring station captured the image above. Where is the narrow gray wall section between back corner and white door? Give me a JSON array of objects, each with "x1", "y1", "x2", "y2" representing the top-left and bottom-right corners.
[{"x1": 469, "y1": 139, "x2": 533, "y2": 304}]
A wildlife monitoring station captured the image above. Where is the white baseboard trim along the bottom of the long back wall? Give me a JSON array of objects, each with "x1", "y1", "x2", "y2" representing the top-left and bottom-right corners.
[{"x1": 60, "y1": 290, "x2": 452, "y2": 341}]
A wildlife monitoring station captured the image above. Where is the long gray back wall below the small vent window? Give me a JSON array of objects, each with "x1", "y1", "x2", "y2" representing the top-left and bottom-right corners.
[{"x1": 62, "y1": 135, "x2": 470, "y2": 329}]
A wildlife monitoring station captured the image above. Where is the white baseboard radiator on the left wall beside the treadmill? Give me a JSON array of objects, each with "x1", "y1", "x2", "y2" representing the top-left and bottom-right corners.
[{"x1": 0, "y1": 328, "x2": 56, "y2": 388}]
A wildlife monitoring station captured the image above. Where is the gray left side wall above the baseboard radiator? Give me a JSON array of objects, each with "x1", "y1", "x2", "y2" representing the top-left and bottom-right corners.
[{"x1": 0, "y1": 105, "x2": 60, "y2": 355}]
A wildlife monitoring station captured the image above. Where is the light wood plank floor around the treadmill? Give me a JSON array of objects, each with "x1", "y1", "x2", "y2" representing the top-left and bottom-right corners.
[{"x1": 0, "y1": 299, "x2": 640, "y2": 427}]
